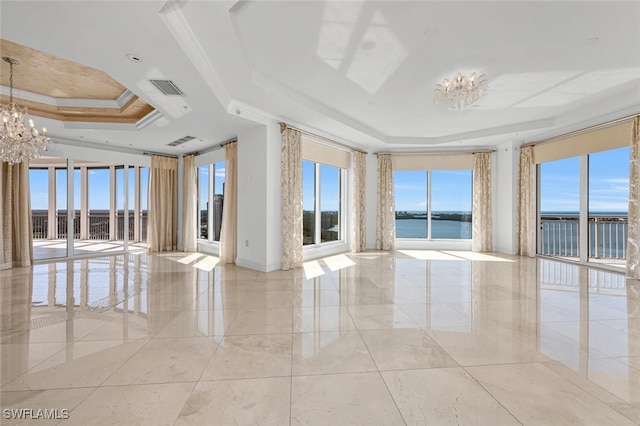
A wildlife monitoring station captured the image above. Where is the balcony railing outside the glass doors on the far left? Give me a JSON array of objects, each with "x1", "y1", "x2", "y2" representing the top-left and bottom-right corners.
[{"x1": 31, "y1": 210, "x2": 147, "y2": 241}]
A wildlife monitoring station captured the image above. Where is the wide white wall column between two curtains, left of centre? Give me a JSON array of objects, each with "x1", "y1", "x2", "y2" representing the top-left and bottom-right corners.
[{"x1": 236, "y1": 122, "x2": 282, "y2": 271}]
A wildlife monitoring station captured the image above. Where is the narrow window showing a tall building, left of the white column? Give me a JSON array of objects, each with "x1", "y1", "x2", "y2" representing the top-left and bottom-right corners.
[{"x1": 198, "y1": 161, "x2": 225, "y2": 241}]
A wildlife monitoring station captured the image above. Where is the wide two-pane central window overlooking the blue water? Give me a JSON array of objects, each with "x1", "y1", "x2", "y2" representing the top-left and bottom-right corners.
[{"x1": 393, "y1": 170, "x2": 472, "y2": 240}]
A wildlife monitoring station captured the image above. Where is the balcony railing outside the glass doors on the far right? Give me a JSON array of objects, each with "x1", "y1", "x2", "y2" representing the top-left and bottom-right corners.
[{"x1": 540, "y1": 214, "x2": 629, "y2": 259}]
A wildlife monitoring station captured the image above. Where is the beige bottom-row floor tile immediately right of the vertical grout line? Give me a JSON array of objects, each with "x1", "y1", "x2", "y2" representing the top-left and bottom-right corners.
[{"x1": 291, "y1": 373, "x2": 404, "y2": 425}]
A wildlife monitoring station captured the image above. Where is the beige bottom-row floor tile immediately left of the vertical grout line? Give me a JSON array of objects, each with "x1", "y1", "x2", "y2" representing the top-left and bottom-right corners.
[{"x1": 175, "y1": 378, "x2": 291, "y2": 426}]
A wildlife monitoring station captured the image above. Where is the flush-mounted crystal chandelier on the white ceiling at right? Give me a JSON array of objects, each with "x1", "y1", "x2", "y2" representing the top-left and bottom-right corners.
[{"x1": 433, "y1": 73, "x2": 489, "y2": 109}]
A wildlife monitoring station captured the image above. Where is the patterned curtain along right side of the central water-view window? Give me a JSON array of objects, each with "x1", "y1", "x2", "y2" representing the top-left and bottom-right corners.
[{"x1": 471, "y1": 152, "x2": 493, "y2": 252}]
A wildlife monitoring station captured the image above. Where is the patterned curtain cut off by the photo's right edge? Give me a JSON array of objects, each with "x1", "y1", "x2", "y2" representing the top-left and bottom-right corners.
[{"x1": 627, "y1": 116, "x2": 640, "y2": 280}]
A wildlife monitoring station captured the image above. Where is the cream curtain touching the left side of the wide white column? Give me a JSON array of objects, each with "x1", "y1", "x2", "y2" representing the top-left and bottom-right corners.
[{"x1": 220, "y1": 142, "x2": 238, "y2": 263}]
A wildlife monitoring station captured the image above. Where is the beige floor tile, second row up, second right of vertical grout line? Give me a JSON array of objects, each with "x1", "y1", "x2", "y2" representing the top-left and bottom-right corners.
[{"x1": 361, "y1": 329, "x2": 458, "y2": 371}]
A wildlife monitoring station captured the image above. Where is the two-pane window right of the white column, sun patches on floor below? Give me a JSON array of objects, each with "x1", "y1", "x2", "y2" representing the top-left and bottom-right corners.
[{"x1": 302, "y1": 161, "x2": 346, "y2": 246}]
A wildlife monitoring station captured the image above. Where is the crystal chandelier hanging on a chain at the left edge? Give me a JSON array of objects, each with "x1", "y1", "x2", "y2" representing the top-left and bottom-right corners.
[{"x1": 0, "y1": 57, "x2": 51, "y2": 164}]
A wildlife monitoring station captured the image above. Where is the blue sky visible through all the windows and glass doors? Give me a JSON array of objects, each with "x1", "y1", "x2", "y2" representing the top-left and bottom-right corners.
[{"x1": 30, "y1": 148, "x2": 629, "y2": 213}]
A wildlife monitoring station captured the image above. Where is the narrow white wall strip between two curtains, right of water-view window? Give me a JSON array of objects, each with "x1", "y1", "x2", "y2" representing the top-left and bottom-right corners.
[{"x1": 493, "y1": 141, "x2": 521, "y2": 254}]
